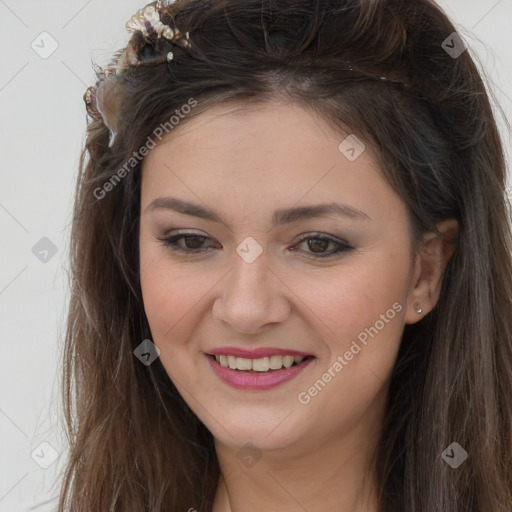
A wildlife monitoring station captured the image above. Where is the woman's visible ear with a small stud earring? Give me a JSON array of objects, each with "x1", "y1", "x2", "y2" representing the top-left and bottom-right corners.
[{"x1": 405, "y1": 219, "x2": 459, "y2": 324}]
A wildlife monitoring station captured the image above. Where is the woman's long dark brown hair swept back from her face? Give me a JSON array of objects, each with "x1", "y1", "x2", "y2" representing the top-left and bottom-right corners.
[{"x1": 59, "y1": 0, "x2": 512, "y2": 512}]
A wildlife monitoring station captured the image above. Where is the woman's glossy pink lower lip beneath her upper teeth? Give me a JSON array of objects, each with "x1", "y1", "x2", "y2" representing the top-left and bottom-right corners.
[{"x1": 206, "y1": 355, "x2": 313, "y2": 391}]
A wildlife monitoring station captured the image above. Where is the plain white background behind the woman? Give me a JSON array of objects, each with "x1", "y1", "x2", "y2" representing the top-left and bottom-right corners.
[{"x1": 0, "y1": 0, "x2": 512, "y2": 512}]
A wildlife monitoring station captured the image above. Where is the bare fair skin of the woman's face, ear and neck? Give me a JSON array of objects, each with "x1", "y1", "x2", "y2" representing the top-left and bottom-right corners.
[{"x1": 139, "y1": 100, "x2": 457, "y2": 512}]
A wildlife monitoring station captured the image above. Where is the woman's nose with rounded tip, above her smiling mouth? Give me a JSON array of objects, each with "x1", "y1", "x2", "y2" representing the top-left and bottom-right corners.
[{"x1": 212, "y1": 253, "x2": 290, "y2": 334}]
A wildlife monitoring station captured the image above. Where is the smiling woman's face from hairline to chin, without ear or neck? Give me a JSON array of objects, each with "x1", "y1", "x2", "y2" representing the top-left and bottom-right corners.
[{"x1": 139, "y1": 102, "x2": 413, "y2": 456}]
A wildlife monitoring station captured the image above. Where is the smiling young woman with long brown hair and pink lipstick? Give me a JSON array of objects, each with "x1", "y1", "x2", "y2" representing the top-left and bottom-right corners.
[{"x1": 59, "y1": 0, "x2": 512, "y2": 512}]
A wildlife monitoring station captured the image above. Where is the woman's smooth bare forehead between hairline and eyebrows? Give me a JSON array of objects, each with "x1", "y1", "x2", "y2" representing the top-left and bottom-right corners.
[{"x1": 141, "y1": 98, "x2": 403, "y2": 228}]
